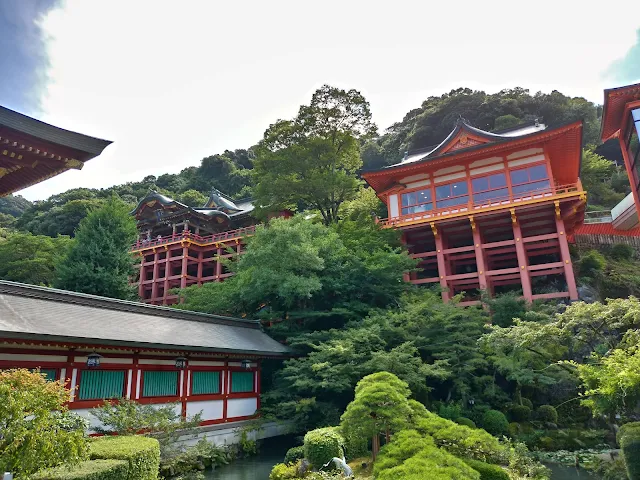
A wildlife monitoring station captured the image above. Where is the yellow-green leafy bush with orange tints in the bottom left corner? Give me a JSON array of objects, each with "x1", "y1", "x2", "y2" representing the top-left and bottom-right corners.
[{"x1": 0, "y1": 369, "x2": 87, "y2": 478}]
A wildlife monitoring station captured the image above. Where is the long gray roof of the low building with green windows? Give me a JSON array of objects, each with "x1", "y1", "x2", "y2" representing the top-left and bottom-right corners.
[{"x1": 0, "y1": 280, "x2": 289, "y2": 356}]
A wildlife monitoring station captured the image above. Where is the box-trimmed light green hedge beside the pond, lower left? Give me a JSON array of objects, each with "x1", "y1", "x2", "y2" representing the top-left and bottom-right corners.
[{"x1": 89, "y1": 435, "x2": 160, "y2": 480}]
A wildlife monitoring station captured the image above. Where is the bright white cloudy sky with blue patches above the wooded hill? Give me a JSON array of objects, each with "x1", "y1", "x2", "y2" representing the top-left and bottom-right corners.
[{"x1": 0, "y1": 0, "x2": 640, "y2": 200}]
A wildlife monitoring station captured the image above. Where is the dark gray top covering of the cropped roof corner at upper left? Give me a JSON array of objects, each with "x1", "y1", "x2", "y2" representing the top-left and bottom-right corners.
[{"x1": 0, "y1": 105, "x2": 111, "y2": 158}]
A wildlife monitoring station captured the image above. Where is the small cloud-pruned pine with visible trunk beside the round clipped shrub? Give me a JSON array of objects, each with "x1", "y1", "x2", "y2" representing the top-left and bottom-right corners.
[{"x1": 341, "y1": 372, "x2": 411, "y2": 461}]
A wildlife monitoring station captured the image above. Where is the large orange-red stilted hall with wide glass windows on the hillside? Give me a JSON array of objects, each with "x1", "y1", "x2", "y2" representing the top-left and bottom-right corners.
[{"x1": 363, "y1": 119, "x2": 586, "y2": 305}]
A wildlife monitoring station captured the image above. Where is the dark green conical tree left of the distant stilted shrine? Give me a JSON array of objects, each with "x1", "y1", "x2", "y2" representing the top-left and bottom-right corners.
[{"x1": 56, "y1": 197, "x2": 137, "y2": 299}]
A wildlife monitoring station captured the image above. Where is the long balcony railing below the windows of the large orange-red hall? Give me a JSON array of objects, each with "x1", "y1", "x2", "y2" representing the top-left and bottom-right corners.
[{"x1": 380, "y1": 183, "x2": 583, "y2": 226}]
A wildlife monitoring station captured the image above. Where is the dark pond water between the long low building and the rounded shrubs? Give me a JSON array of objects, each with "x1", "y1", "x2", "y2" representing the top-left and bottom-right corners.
[{"x1": 205, "y1": 436, "x2": 295, "y2": 480}]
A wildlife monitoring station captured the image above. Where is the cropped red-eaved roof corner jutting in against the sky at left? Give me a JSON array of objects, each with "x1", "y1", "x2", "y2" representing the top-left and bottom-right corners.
[{"x1": 0, "y1": 106, "x2": 111, "y2": 197}]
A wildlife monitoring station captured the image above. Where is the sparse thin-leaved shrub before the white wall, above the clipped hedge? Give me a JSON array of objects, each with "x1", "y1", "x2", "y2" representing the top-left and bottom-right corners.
[{"x1": 91, "y1": 398, "x2": 202, "y2": 460}]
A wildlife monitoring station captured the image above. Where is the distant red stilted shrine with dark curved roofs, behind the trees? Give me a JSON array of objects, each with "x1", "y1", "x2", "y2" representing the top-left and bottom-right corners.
[{"x1": 131, "y1": 189, "x2": 257, "y2": 305}]
